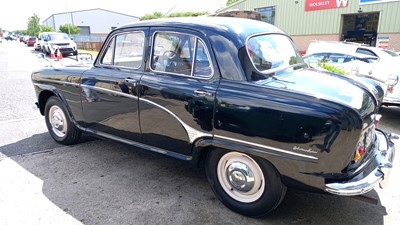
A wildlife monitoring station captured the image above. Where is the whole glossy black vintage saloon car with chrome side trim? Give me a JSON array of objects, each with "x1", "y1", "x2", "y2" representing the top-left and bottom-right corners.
[{"x1": 32, "y1": 17, "x2": 398, "y2": 217}]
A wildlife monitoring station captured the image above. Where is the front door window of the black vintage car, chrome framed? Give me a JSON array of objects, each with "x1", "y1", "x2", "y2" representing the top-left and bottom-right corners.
[{"x1": 100, "y1": 32, "x2": 145, "y2": 69}]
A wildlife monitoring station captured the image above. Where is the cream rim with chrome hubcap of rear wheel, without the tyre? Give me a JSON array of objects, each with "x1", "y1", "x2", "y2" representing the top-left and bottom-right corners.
[{"x1": 217, "y1": 152, "x2": 265, "y2": 203}]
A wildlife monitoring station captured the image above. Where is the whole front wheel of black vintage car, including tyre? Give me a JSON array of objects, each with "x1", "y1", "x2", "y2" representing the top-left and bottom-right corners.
[{"x1": 45, "y1": 96, "x2": 81, "y2": 145}]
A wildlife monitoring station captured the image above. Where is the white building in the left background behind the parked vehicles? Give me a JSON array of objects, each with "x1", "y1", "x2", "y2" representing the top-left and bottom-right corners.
[{"x1": 42, "y1": 8, "x2": 139, "y2": 36}]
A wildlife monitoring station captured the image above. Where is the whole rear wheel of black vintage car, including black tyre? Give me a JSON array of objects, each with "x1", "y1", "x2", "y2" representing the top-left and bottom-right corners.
[{"x1": 206, "y1": 149, "x2": 286, "y2": 217}]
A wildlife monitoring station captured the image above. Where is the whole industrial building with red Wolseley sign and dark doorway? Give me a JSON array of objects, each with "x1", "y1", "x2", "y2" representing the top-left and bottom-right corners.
[{"x1": 219, "y1": 0, "x2": 400, "y2": 51}]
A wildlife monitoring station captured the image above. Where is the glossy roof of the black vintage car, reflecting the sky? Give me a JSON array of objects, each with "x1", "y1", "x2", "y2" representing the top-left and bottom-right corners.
[{"x1": 119, "y1": 16, "x2": 284, "y2": 40}]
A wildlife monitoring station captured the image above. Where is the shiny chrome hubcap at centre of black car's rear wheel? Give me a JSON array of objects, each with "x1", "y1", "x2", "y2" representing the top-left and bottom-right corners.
[{"x1": 226, "y1": 162, "x2": 254, "y2": 192}]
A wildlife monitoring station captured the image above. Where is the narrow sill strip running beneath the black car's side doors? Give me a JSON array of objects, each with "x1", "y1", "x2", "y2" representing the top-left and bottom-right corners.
[{"x1": 85, "y1": 129, "x2": 193, "y2": 161}]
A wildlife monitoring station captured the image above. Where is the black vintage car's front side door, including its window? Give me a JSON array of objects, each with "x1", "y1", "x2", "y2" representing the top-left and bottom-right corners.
[{"x1": 81, "y1": 28, "x2": 148, "y2": 141}]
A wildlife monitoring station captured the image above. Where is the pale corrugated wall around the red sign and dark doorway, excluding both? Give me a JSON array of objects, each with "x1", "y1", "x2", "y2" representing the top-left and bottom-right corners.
[{"x1": 222, "y1": 0, "x2": 400, "y2": 35}]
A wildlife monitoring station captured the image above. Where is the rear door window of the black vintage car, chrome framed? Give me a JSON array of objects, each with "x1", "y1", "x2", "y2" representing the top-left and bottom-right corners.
[{"x1": 150, "y1": 32, "x2": 212, "y2": 78}]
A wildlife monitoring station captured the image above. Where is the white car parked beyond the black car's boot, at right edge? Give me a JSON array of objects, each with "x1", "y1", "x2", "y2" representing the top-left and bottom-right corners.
[{"x1": 304, "y1": 41, "x2": 400, "y2": 106}]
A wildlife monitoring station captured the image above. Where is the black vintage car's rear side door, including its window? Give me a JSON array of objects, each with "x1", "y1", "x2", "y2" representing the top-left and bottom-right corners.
[{"x1": 139, "y1": 28, "x2": 219, "y2": 155}]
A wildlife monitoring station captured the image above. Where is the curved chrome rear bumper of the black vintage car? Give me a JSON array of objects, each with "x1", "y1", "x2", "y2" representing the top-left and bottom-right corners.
[{"x1": 325, "y1": 130, "x2": 400, "y2": 196}]
